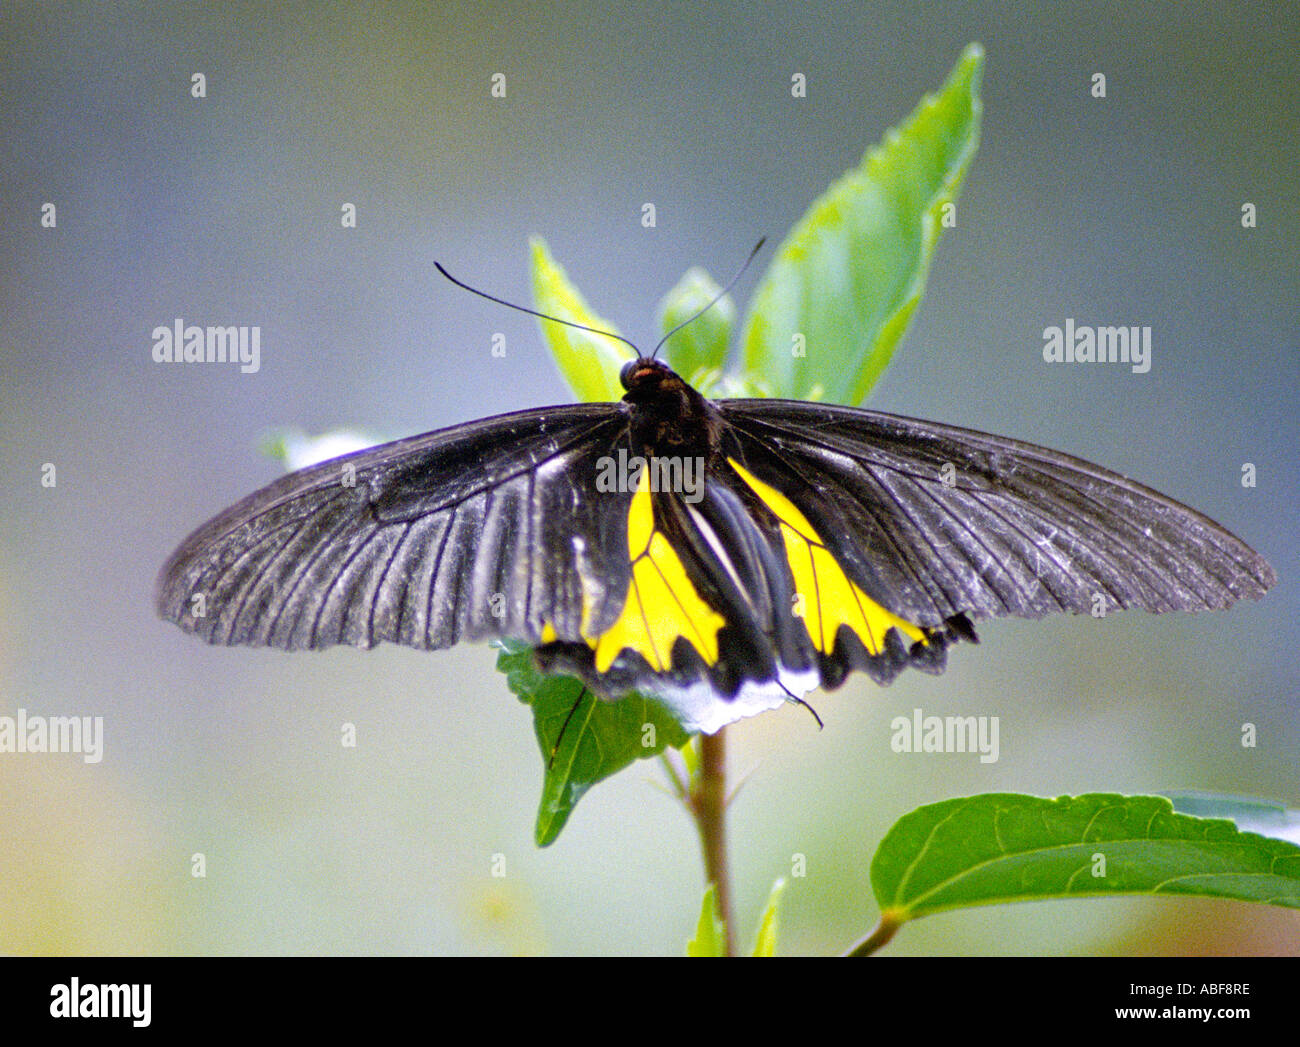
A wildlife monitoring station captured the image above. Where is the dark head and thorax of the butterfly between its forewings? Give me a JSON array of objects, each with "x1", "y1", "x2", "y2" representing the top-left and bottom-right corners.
[{"x1": 619, "y1": 356, "x2": 723, "y2": 460}]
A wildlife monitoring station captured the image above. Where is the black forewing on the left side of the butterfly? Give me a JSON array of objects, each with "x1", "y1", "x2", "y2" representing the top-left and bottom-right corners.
[{"x1": 156, "y1": 403, "x2": 628, "y2": 649}]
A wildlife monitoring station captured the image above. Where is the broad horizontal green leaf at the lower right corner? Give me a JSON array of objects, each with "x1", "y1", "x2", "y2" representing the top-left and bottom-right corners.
[{"x1": 871, "y1": 793, "x2": 1300, "y2": 922}]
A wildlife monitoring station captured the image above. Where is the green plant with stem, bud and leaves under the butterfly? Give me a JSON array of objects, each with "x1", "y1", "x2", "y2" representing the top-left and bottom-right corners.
[{"x1": 498, "y1": 44, "x2": 1300, "y2": 956}]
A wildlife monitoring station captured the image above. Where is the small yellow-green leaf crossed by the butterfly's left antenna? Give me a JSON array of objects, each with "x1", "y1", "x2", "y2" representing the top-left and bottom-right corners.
[{"x1": 530, "y1": 237, "x2": 634, "y2": 402}]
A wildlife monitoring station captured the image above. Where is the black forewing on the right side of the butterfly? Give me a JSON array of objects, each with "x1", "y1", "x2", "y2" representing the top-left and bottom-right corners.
[{"x1": 718, "y1": 399, "x2": 1275, "y2": 627}]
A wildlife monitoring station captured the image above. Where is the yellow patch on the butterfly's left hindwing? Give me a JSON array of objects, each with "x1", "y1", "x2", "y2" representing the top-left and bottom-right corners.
[{"x1": 574, "y1": 470, "x2": 727, "y2": 672}]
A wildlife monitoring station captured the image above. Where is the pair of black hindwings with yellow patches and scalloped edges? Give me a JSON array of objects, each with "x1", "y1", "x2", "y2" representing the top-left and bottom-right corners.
[{"x1": 541, "y1": 449, "x2": 951, "y2": 700}]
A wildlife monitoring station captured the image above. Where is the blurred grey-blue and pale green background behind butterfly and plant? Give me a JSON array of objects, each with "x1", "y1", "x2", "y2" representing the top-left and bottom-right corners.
[{"x1": 0, "y1": 3, "x2": 1300, "y2": 953}]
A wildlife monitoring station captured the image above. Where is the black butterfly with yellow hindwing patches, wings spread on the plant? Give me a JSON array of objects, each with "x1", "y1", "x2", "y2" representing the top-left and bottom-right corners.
[{"x1": 156, "y1": 257, "x2": 1275, "y2": 732}]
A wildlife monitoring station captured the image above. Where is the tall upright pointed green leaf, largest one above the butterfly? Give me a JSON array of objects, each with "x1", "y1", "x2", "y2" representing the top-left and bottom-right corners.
[{"x1": 742, "y1": 44, "x2": 984, "y2": 404}]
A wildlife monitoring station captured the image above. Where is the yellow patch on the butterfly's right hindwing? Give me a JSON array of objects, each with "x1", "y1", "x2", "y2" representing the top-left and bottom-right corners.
[{"x1": 727, "y1": 459, "x2": 926, "y2": 654}]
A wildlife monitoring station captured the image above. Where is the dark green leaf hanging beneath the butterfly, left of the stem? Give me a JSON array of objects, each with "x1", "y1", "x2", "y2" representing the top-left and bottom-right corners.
[{"x1": 497, "y1": 644, "x2": 689, "y2": 847}]
